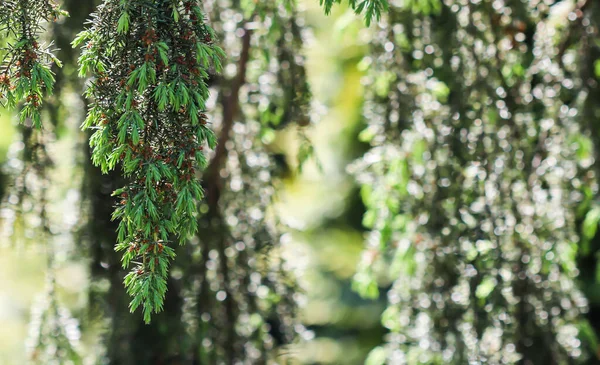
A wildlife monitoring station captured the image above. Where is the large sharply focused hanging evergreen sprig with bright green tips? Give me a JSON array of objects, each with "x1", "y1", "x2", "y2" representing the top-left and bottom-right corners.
[{"x1": 74, "y1": 0, "x2": 224, "y2": 322}]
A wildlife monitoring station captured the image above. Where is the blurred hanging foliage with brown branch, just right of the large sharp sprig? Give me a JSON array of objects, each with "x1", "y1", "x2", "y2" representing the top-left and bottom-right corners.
[{"x1": 180, "y1": 0, "x2": 310, "y2": 363}]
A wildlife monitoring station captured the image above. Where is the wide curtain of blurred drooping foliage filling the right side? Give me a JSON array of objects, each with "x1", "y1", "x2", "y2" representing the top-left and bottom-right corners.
[{"x1": 352, "y1": 0, "x2": 597, "y2": 364}]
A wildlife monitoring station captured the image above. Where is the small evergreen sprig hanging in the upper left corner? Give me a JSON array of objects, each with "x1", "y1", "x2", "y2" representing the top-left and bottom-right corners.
[{"x1": 0, "y1": 0, "x2": 66, "y2": 128}]
